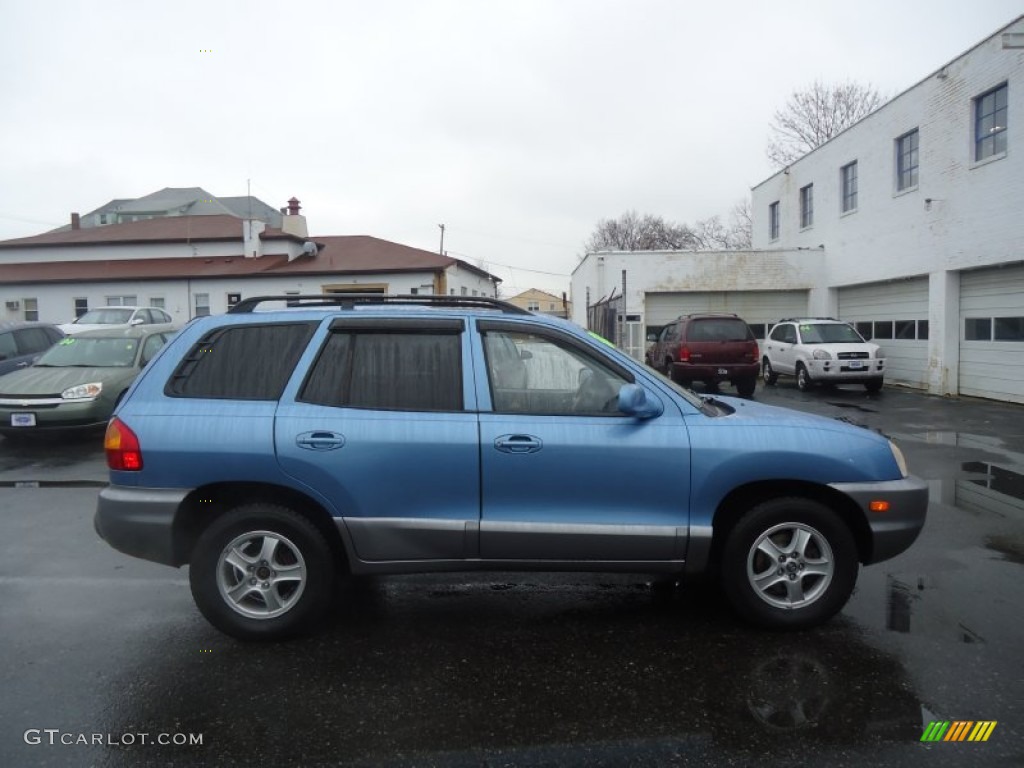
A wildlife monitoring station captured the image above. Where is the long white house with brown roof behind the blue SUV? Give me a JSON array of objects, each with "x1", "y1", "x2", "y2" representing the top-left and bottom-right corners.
[{"x1": 0, "y1": 198, "x2": 501, "y2": 323}]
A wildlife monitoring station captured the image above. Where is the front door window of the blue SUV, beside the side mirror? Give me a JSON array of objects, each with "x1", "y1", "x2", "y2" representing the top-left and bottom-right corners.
[{"x1": 483, "y1": 330, "x2": 632, "y2": 416}]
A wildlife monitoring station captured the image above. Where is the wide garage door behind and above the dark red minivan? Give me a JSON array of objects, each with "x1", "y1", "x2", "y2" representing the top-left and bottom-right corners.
[{"x1": 644, "y1": 291, "x2": 807, "y2": 339}]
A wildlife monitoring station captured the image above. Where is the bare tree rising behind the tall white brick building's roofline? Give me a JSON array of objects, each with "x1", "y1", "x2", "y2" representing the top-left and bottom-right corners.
[{"x1": 767, "y1": 81, "x2": 886, "y2": 168}]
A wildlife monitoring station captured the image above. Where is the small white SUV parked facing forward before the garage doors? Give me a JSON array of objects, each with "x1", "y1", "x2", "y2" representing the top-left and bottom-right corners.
[{"x1": 761, "y1": 317, "x2": 886, "y2": 392}]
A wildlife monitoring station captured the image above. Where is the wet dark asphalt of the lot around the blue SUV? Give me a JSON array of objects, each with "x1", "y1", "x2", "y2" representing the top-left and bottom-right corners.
[{"x1": 0, "y1": 382, "x2": 1024, "y2": 768}]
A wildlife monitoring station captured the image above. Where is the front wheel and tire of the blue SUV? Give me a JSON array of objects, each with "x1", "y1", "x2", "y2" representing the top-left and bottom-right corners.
[{"x1": 722, "y1": 498, "x2": 858, "y2": 629}]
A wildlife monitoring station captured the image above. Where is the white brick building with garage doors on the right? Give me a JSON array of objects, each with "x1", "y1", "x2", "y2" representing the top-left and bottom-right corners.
[{"x1": 572, "y1": 16, "x2": 1024, "y2": 402}]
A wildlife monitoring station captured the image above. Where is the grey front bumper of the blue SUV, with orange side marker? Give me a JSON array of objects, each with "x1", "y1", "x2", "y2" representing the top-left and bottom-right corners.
[{"x1": 829, "y1": 476, "x2": 928, "y2": 563}]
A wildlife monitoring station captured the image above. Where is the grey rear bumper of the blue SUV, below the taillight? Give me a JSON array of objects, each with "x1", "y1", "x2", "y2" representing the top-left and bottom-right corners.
[{"x1": 93, "y1": 485, "x2": 189, "y2": 565}]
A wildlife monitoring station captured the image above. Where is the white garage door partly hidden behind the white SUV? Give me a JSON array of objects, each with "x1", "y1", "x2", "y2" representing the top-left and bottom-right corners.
[{"x1": 839, "y1": 278, "x2": 928, "y2": 387}]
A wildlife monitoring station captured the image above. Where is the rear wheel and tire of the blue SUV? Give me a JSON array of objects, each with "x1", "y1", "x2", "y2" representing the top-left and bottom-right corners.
[{"x1": 188, "y1": 504, "x2": 336, "y2": 640}]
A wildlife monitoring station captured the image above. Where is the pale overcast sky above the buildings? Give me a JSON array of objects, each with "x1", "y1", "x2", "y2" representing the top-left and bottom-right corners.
[{"x1": 0, "y1": 0, "x2": 1024, "y2": 295}]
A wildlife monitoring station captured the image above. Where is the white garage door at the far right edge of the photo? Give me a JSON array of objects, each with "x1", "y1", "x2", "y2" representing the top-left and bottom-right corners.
[{"x1": 959, "y1": 266, "x2": 1024, "y2": 402}]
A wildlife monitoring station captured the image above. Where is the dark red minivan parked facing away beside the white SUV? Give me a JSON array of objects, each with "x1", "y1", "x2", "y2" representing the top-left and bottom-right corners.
[{"x1": 647, "y1": 312, "x2": 760, "y2": 397}]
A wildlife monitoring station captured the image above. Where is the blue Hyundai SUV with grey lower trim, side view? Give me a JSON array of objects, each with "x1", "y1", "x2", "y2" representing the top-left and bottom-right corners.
[{"x1": 95, "y1": 296, "x2": 928, "y2": 639}]
